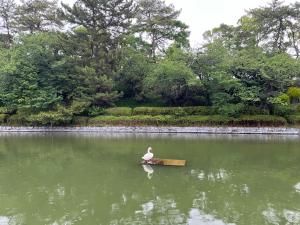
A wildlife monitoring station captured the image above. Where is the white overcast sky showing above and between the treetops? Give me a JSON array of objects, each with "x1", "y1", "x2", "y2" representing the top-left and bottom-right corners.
[{"x1": 63, "y1": 0, "x2": 297, "y2": 46}]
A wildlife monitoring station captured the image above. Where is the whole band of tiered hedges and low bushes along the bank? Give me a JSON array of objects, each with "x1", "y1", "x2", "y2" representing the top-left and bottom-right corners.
[{"x1": 0, "y1": 106, "x2": 300, "y2": 127}]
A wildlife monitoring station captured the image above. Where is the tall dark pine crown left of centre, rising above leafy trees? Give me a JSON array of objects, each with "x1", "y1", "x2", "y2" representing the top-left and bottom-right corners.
[{"x1": 62, "y1": 0, "x2": 134, "y2": 73}]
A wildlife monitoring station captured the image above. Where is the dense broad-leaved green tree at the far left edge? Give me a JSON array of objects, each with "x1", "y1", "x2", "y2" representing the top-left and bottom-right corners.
[{"x1": 0, "y1": 34, "x2": 61, "y2": 112}]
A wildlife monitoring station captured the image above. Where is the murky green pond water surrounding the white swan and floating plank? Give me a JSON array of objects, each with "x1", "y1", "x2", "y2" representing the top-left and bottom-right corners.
[{"x1": 0, "y1": 133, "x2": 300, "y2": 225}]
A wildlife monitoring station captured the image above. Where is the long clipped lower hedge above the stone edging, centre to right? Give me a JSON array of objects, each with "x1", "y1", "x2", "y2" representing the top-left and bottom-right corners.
[{"x1": 87, "y1": 115, "x2": 287, "y2": 126}]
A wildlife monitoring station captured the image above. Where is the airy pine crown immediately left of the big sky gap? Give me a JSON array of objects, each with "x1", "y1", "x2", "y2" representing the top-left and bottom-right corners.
[{"x1": 136, "y1": 0, "x2": 189, "y2": 58}]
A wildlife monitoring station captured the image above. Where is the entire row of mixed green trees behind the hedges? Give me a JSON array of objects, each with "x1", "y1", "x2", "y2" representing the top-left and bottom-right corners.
[{"x1": 0, "y1": 0, "x2": 300, "y2": 118}]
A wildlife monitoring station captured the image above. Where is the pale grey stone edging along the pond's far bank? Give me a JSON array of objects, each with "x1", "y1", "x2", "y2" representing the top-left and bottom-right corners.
[{"x1": 0, "y1": 126, "x2": 300, "y2": 136}]
